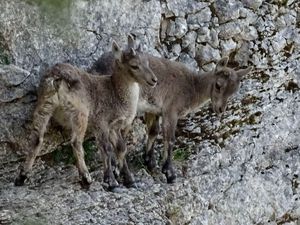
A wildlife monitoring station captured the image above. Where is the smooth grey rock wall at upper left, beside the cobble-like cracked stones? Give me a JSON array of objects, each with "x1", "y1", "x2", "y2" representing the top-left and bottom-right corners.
[{"x1": 0, "y1": 0, "x2": 160, "y2": 160}]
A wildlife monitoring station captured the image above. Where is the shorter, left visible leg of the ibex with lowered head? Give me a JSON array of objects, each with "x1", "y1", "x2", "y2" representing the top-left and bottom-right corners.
[{"x1": 144, "y1": 113, "x2": 159, "y2": 172}]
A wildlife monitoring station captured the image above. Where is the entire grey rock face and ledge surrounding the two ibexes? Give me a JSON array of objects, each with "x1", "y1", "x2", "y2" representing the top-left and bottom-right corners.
[{"x1": 0, "y1": 0, "x2": 300, "y2": 225}]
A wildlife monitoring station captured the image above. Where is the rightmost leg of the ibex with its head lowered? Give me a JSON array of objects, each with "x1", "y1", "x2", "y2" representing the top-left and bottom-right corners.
[{"x1": 162, "y1": 113, "x2": 178, "y2": 183}]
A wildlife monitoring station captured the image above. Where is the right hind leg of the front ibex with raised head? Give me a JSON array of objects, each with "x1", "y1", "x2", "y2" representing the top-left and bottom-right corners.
[{"x1": 71, "y1": 112, "x2": 92, "y2": 188}]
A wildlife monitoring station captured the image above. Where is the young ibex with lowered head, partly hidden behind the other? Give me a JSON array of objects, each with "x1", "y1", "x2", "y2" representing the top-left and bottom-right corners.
[{"x1": 91, "y1": 36, "x2": 252, "y2": 183}]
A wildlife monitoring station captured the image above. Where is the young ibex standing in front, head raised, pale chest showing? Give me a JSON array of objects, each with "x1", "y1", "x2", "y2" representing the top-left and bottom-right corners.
[{"x1": 15, "y1": 42, "x2": 157, "y2": 188}]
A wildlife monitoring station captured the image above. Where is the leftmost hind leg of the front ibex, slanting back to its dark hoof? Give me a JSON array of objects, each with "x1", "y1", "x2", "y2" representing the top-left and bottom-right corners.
[{"x1": 15, "y1": 101, "x2": 54, "y2": 186}]
